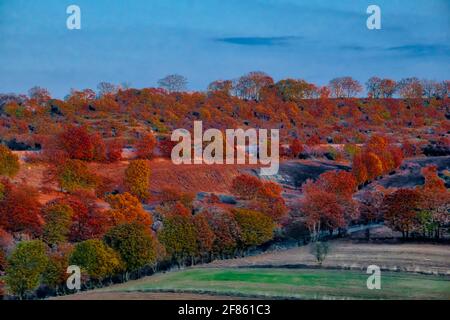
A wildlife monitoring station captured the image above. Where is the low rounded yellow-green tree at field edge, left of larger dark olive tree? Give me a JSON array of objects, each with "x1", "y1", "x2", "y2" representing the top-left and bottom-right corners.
[{"x1": 69, "y1": 239, "x2": 122, "y2": 280}]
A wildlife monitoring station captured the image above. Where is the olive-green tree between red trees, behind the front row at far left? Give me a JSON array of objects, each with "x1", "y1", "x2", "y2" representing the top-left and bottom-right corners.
[{"x1": 42, "y1": 203, "x2": 73, "y2": 245}]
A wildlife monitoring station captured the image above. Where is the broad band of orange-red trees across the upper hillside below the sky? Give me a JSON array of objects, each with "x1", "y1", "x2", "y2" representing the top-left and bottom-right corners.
[{"x1": 0, "y1": 80, "x2": 447, "y2": 151}]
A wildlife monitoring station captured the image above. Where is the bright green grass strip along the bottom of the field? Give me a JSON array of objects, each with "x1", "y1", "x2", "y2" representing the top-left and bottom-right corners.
[{"x1": 105, "y1": 268, "x2": 450, "y2": 299}]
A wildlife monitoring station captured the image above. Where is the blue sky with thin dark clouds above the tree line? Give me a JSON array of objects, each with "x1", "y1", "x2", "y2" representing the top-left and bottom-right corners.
[{"x1": 0, "y1": 0, "x2": 450, "y2": 97}]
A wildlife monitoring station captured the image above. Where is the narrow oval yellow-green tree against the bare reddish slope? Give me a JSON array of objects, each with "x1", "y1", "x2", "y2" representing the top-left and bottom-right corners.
[{"x1": 125, "y1": 160, "x2": 151, "y2": 201}]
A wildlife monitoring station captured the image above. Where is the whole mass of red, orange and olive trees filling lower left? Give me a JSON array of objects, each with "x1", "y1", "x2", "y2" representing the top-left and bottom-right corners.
[{"x1": 0, "y1": 150, "x2": 281, "y2": 297}]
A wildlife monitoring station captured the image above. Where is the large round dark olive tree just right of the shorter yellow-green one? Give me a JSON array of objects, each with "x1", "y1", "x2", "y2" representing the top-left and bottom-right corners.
[{"x1": 103, "y1": 222, "x2": 156, "y2": 271}]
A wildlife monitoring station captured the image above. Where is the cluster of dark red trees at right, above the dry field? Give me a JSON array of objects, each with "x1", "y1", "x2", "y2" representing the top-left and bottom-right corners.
[{"x1": 298, "y1": 166, "x2": 450, "y2": 239}]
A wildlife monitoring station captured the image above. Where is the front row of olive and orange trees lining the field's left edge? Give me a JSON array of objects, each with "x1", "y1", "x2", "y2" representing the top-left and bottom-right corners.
[{"x1": 0, "y1": 194, "x2": 274, "y2": 297}]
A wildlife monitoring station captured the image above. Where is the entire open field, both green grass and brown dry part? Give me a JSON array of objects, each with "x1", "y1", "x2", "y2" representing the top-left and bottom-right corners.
[{"x1": 54, "y1": 240, "x2": 450, "y2": 300}]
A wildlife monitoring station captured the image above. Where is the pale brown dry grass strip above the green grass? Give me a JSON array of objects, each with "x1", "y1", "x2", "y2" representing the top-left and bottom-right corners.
[{"x1": 202, "y1": 240, "x2": 450, "y2": 275}]
